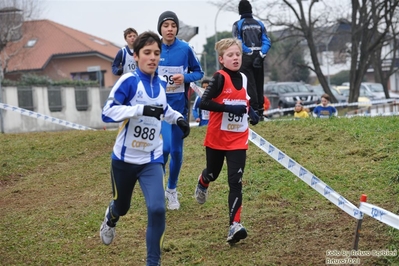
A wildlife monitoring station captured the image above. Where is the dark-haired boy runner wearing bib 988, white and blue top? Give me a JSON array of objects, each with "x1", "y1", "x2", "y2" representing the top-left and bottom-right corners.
[{"x1": 100, "y1": 32, "x2": 190, "y2": 266}]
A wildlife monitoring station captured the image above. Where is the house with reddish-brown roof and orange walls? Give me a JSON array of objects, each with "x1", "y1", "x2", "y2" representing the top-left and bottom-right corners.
[{"x1": 0, "y1": 20, "x2": 121, "y2": 87}]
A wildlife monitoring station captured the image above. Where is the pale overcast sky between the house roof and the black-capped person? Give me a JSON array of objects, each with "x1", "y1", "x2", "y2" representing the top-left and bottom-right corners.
[{"x1": 39, "y1": 0, "x2": 239, "y2": 53}]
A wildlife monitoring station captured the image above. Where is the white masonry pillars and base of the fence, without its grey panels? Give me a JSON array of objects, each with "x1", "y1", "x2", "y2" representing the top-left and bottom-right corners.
[{"x1": 0, "y1": 87, "x2": 118, "y2": 133}]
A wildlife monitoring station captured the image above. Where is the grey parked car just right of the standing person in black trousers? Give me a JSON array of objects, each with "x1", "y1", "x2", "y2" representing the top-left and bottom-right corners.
[{"x1": 263, "y1": 82, "x2": 319, "y2": 114}]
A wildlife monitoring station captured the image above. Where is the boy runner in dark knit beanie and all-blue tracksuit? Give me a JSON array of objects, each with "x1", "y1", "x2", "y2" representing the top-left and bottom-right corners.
[{"x1": 158, "y1": 11, "x2": 204, "y2": 210}]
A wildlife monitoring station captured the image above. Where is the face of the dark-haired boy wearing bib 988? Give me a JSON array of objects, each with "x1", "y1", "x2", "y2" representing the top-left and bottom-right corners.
[{"x1": 133, "y1": 42, "x2": 161, "y2": 75}]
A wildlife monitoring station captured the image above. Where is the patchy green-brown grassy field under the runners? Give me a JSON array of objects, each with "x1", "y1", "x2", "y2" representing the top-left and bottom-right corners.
[{"x1": 0, "y1": 117, "x2": 399, "y2": 266}]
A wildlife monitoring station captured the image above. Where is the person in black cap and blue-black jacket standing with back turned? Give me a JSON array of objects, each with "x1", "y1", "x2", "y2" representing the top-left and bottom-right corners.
[{"x1": 233, "y1": 0, "x2": 271, "y2": 121}]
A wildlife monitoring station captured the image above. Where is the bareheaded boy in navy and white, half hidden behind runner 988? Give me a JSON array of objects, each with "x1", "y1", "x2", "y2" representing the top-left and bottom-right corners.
[{"x1": 112, "y1": 28, "x2": 138, "y2": 76}]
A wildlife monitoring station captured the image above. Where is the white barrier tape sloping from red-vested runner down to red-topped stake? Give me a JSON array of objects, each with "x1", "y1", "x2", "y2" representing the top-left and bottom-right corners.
[{"x1": 191, "y1": 83, "x2": 362, "y2": 219}]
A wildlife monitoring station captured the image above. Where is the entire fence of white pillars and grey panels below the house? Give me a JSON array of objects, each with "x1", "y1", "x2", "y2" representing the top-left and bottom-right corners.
[{"x1": 0, "y1": 87, "x2": 118, "y2": 133}]
